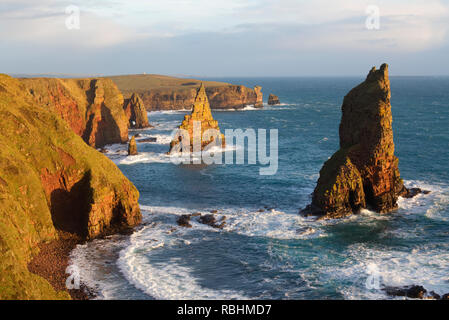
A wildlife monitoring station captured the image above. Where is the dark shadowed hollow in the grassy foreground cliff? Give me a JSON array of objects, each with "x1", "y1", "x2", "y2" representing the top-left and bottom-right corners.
[{"x1": 50, "y1": 170, "x2": 93, "y2": 238}]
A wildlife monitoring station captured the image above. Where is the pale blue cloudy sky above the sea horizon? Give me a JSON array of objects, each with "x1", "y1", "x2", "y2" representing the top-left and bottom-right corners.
[{"x1": 0, "y1": 0, "x2": 449, "y2": 77}]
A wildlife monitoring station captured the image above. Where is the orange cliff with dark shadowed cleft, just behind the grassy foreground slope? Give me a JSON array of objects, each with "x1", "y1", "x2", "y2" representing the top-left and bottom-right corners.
[{"x1": 21, "y1": 78, "x2": 128, "y2": 148}]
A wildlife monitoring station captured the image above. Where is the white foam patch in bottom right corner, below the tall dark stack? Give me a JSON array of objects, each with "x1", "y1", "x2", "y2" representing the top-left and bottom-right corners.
[{"x1": 330, "y1": 244, "x2": 449, "y2": 299}]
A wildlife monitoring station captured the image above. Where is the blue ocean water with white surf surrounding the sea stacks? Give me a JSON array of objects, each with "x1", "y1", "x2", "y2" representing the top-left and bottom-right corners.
[{"x1": 71, "y1": 77, "x2": 449, "y2": 299}]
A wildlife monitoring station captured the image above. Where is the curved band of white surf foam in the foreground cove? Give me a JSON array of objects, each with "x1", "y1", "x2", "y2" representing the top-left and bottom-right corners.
[{"x1": 118, "y1": 206, "x2": 246, "y2": 300}]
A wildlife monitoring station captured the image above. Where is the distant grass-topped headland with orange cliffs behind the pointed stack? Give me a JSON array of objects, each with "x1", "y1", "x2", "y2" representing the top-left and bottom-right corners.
[{"x1": 110, "y1": 75, "x2": 263, "y2": 111}]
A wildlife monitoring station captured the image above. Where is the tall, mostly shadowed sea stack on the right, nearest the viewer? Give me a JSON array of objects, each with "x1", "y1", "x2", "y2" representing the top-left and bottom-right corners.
[{"x1": 302, "y1": 64, "x2": 407, "y2": 218}]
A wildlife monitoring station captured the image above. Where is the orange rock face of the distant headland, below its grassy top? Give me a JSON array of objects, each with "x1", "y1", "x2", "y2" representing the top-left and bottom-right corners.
[{"x1": 130, "y1": 85, "x2": 263, "y2": 111}]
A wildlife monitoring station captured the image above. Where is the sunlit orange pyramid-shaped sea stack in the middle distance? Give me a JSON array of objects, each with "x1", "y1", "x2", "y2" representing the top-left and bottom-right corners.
[{"x1": 169, "y1": 84, "x2": 225, "y2": 153}]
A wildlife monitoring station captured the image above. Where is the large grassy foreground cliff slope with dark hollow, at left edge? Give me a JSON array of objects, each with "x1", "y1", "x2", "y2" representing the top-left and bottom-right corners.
[{"x1": 0, "y1": 75, "x2": 141, "y2": 299}]
